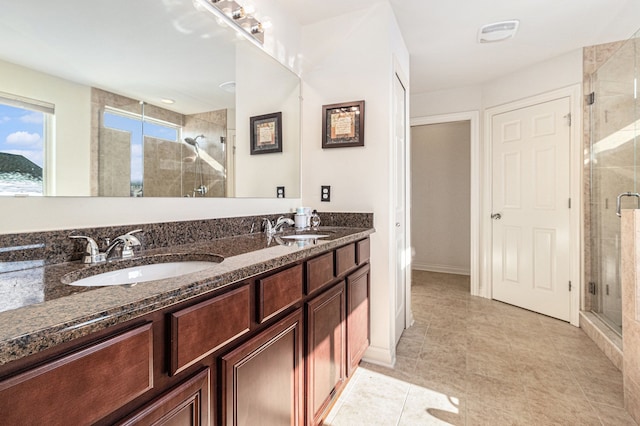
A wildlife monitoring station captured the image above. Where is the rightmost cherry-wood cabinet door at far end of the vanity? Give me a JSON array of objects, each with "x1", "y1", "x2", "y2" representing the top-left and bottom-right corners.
[{"x1": 347, "y1": 265, "x2": 369, "y2": 376}]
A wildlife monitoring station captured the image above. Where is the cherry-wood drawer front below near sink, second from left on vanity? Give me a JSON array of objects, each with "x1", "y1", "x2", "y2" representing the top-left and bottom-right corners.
[{"x1": 170, "y1": 285, "x2": 251, "y2": 374}]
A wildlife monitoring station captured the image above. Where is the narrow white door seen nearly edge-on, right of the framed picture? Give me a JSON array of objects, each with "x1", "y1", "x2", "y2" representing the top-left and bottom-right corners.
[{"x1": 393, "y1": 75, "x2": 408, "y2": 344}]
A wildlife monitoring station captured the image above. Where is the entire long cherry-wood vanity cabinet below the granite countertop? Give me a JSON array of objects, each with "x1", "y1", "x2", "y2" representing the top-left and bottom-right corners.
[{"x1": 0, "y1": 238, "x2": 369, "y2": 426}]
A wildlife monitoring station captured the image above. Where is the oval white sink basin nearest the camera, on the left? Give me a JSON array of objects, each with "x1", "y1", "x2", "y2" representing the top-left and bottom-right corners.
[{"x1": 69, "y1": 261, "x2": 218, "y2": 287}]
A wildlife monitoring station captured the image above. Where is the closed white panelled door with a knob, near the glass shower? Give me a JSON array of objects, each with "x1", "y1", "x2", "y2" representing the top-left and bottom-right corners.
[{"x1": 491, "y1": 98, "x2": 571, "y2": 321}]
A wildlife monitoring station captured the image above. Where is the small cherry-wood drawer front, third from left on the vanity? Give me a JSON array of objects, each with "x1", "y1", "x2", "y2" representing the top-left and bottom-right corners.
[{"x1": 258, "y1": 265, "x2": 302, "y2": 323}]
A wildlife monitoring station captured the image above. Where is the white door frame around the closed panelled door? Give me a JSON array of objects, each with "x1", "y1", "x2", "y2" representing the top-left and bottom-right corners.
[{"x1": 479, "y1": 84, "x2": 584, "y2": 327}]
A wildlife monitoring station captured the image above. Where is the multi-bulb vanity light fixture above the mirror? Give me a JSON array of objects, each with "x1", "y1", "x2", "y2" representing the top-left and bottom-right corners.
[{"x1": 193, "y1": 0, "x2": 266, "y2": 47}]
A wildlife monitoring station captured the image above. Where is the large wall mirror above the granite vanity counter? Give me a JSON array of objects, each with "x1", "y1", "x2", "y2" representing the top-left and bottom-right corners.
[{"x1": 0, "y1": 0, "x2": 300, "y2": 198}]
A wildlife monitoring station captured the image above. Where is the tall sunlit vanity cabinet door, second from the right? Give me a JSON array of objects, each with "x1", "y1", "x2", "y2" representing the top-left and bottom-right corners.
[{"x1": 306, "y1": 281, "x2": 346, "y2": 425}]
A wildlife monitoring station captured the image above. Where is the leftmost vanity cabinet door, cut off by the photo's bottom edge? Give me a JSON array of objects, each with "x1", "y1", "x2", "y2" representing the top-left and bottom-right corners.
[{"x1": 117, "y1": 368, "x2": 213, "y2": 426}]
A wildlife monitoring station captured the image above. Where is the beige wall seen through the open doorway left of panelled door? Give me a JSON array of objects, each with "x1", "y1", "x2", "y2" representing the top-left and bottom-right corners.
[{"x1": 411, "y1": 121, "x2": 471, "y2": 275}]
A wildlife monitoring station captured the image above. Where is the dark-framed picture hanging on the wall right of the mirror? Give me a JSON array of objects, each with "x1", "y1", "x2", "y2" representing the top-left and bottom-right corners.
[{"x1": 322, "y1": 101, "x2": 364, "y2": 148}]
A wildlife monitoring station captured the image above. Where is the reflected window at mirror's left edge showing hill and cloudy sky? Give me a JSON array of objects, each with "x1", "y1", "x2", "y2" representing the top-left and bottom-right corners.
[{"x1": 0, "y1": 93, "x2": 54, "y2": 195}]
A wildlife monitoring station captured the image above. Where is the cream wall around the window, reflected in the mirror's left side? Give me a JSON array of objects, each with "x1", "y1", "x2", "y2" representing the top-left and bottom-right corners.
[{"x1": 0, "y1": 61, "x2": 91, "y2": 195}]
